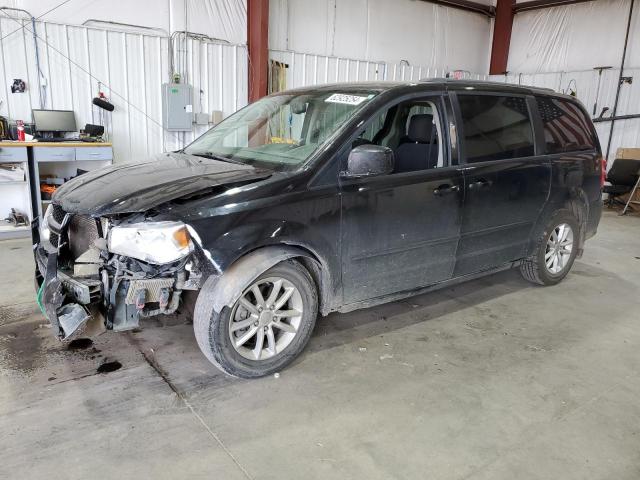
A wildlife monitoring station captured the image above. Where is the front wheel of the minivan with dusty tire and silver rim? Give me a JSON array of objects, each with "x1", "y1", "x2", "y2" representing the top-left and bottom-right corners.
[{"x1": 193, "y1": 260, "x2": 318, "y2": 378}]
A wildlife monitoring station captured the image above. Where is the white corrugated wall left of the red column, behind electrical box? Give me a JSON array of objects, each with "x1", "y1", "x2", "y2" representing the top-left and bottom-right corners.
[{"x1": 0, "y1": 18, "x2": 248, "y2": 162}]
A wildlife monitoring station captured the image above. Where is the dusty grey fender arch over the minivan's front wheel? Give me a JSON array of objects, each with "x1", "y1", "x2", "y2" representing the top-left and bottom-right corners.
[{"x1": 196, "y1": 245, "x2": 315, "y2": 314}]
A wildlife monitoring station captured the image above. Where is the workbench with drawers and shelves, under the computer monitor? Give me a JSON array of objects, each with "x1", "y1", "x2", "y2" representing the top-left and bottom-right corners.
[{"x1": 0, "y1": 141, "x2": 113, "y2": 239}]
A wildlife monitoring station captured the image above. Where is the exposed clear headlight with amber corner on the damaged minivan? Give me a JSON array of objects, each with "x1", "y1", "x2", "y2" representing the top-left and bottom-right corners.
[{"x1": 108, "y1": 222, "x2": 192, "y2": 265}]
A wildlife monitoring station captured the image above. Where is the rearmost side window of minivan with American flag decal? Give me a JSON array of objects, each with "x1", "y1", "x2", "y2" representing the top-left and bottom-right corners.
[{"x1": 537, "y1": 97, "x2": 595, "y2": 153}]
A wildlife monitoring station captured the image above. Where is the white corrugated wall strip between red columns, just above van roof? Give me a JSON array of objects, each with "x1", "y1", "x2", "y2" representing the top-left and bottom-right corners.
[{"x1": 269, "y1": 50, "x2": 487, "y2": 88}]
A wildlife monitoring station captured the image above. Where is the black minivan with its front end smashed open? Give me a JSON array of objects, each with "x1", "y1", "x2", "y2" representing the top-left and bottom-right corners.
[{"x1": 33, "y1": 80, "x2": 604, "y2": 378}]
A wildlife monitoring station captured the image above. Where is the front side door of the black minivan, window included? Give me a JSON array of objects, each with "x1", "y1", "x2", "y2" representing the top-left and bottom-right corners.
[{"x1": 340, "y1": 97, "x2": 463, "y2": 305}]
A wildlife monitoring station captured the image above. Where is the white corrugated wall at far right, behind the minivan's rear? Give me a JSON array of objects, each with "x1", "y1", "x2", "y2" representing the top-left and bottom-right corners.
[{"x1": 490, "y1": 68, "x2": 640, "y2": 166}]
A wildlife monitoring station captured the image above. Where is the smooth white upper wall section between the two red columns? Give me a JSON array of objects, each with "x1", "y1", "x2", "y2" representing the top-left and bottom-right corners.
[{"x1": 269, "y1": 0, "x2": 493, "y2": 72}]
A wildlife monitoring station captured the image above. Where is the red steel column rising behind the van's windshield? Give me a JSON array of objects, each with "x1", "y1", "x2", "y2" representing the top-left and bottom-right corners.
[{"x1": 247, "y1": 0, "x2": 269, "y2": 102}]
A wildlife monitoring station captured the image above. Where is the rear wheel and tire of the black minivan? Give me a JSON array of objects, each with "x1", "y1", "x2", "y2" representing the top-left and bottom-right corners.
[{"x1": 520, "y1": 208, "x2": 580, "y2": 285}]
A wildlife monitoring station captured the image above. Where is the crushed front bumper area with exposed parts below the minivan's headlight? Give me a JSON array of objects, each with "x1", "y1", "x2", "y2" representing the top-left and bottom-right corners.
[{"x1": 32, "y1": 220, "x2": 196, "y2": 340}]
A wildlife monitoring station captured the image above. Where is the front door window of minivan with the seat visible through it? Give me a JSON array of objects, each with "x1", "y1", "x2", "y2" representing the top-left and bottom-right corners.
[{"x1": 352, "y1": 96, "x2": 444, "y2": 173}]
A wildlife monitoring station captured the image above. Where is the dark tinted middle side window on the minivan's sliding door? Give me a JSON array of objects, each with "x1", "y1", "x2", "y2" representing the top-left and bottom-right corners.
[{"x1": 458, "y1": 95, "x2": 534, "y2": 163}]
